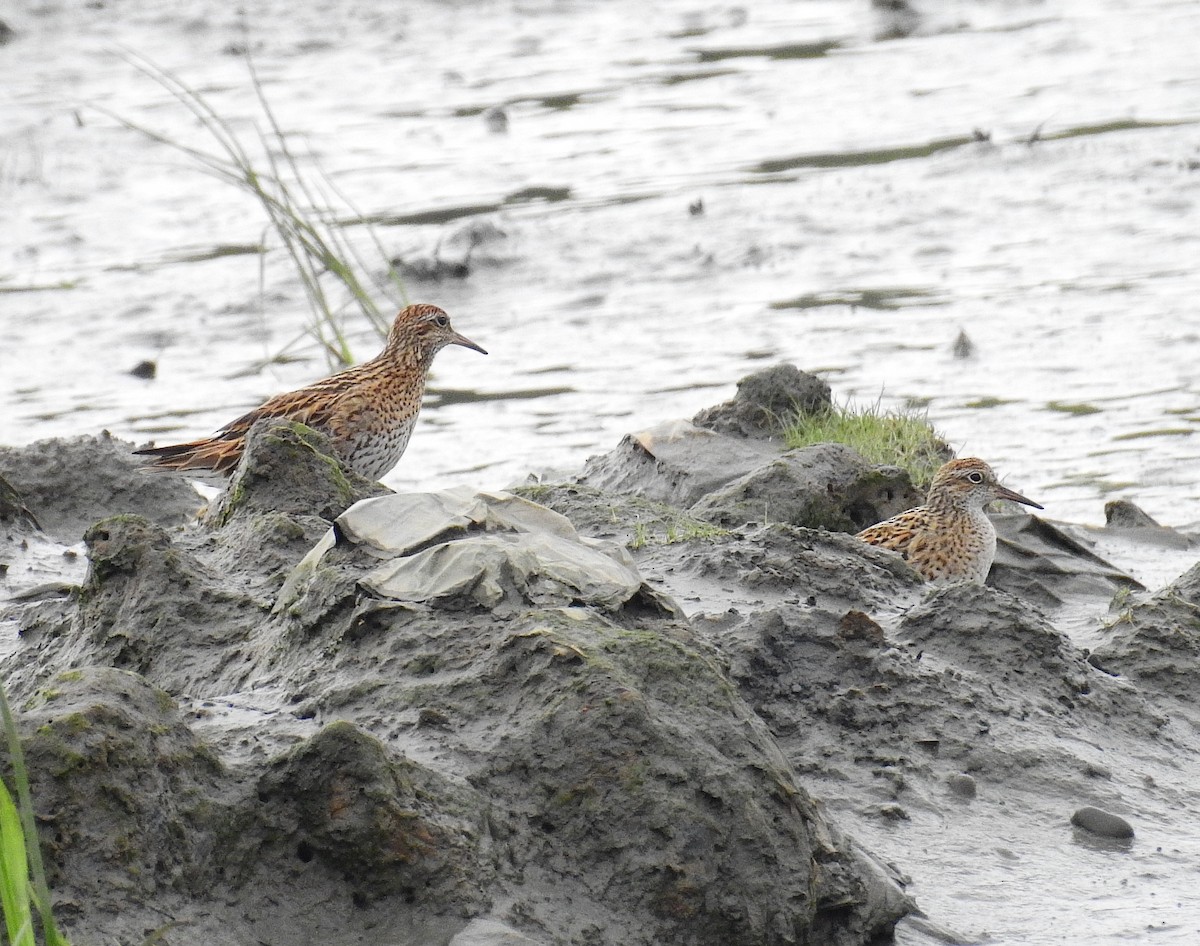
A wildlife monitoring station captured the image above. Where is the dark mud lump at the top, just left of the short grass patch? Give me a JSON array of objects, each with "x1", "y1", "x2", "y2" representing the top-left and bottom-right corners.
[{"x1": 691, "y1": 364, "x2": 833, "y2": 439}]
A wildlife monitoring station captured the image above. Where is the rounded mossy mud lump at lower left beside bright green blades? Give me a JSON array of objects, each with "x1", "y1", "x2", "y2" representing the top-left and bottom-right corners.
[{"x1": 22, "y1": 665, "x2": 232, "y2": 912}]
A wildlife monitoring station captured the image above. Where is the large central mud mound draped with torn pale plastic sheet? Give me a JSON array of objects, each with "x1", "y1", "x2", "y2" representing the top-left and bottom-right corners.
[{"x1": 272, "y1": 492, "x2": 905, "y2": 944}]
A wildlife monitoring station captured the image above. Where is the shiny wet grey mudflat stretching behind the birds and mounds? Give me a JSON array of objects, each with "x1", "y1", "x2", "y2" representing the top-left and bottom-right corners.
[{"x1": 0, "y1": 0, "x2": 1200, "y2": 533}]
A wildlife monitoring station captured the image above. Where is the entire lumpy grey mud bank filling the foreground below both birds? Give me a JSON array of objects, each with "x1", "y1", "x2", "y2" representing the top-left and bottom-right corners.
[{"x1": 7, "y1": 369, "x2": 1200, "y2": 946}]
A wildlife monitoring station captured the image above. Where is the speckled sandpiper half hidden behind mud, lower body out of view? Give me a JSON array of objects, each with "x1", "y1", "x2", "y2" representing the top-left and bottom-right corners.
[{"x1": 858, "y1": 456, "x2": 1043, "y2": 585}]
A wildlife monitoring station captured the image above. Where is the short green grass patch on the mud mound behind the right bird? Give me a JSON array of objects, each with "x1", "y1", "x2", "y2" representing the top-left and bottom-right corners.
[{"x1": 784, "y1": 402, "x2": 953, "y2": 487}]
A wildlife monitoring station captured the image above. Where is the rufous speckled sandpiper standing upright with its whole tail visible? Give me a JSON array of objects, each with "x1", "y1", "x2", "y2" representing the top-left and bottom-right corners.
[{"x1": 134, "y1": 304, "x2": 487, "y2": 479}]
